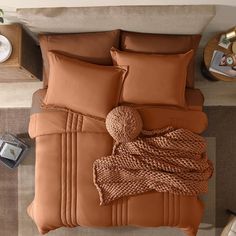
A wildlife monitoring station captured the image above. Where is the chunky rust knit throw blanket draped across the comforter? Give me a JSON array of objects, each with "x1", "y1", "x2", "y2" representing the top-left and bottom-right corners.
[{"x1": 93, "y1": 127, "x2": 213, "y2": 205}]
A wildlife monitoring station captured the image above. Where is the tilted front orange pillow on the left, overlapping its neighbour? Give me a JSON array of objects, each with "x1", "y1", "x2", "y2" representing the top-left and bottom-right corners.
[{"x1": 44, "y1": 52, "x2": 127, "y2": 118}]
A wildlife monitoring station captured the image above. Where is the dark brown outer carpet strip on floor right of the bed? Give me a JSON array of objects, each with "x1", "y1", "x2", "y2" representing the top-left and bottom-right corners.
[{"x1": 204, "y1": 106, "x2": 236, "y2": 227}]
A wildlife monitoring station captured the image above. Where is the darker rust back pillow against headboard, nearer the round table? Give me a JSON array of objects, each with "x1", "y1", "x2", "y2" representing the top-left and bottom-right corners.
[{"x1": 120, "y1": 31, "x2": 201, "y2": 88}]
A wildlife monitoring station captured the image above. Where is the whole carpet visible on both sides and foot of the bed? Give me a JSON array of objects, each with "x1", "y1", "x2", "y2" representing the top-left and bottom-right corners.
[{"x1": 0, "y1": 107, "x2": 230, "y2": 236}]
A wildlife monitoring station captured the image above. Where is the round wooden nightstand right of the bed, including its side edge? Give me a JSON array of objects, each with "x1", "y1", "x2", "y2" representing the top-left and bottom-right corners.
[{"x1": 201, "y1": 32, "x2": 236, "y2": 82}]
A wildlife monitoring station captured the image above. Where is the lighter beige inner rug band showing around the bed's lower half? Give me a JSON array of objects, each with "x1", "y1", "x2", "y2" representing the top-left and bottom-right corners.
[{"x1": 18, "y1": 138, "x2": 215, "y2": 236}]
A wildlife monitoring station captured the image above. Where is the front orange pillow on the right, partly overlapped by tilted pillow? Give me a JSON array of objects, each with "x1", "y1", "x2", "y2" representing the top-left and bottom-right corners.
[{"x1": 111, "y1": 48, "x2": 193, "y2": 107}]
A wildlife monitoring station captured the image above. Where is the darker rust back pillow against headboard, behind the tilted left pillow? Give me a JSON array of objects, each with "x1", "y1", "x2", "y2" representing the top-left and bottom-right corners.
[{"x1": 39, "y1": 30, "x2": 120, "y2": 86}]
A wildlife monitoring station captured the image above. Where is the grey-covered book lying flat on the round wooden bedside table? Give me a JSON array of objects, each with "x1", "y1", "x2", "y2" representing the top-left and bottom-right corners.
[{"x1": 209, "y1": 50, "x2": 236, "y2": 79}]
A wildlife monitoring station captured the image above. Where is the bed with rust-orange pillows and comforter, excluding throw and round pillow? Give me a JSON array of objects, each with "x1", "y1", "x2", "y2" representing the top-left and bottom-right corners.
[{"x1": 28, "y1": 4, "x2": 215, "y2": 236}]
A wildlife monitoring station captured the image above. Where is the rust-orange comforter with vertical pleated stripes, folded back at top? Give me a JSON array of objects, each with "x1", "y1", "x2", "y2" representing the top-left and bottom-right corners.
[{"x1": 28, "y1": 89, "x2": 207, "y2": 236}]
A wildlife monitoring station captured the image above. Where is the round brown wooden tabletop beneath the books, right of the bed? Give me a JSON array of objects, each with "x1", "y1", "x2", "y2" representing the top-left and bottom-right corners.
[{"x1": 204, "y1": 33, "x2": 236, "y2": 82}]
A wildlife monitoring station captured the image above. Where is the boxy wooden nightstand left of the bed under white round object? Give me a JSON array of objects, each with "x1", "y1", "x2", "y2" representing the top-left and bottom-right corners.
[{"x1": 0, "y1": 24, "x2": 42, "y2": 82}]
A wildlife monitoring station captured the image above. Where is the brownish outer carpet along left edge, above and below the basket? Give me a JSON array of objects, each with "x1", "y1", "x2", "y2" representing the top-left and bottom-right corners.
[{"x1": 0, "y1": 108, "x2": 30, "y2": 236}]
